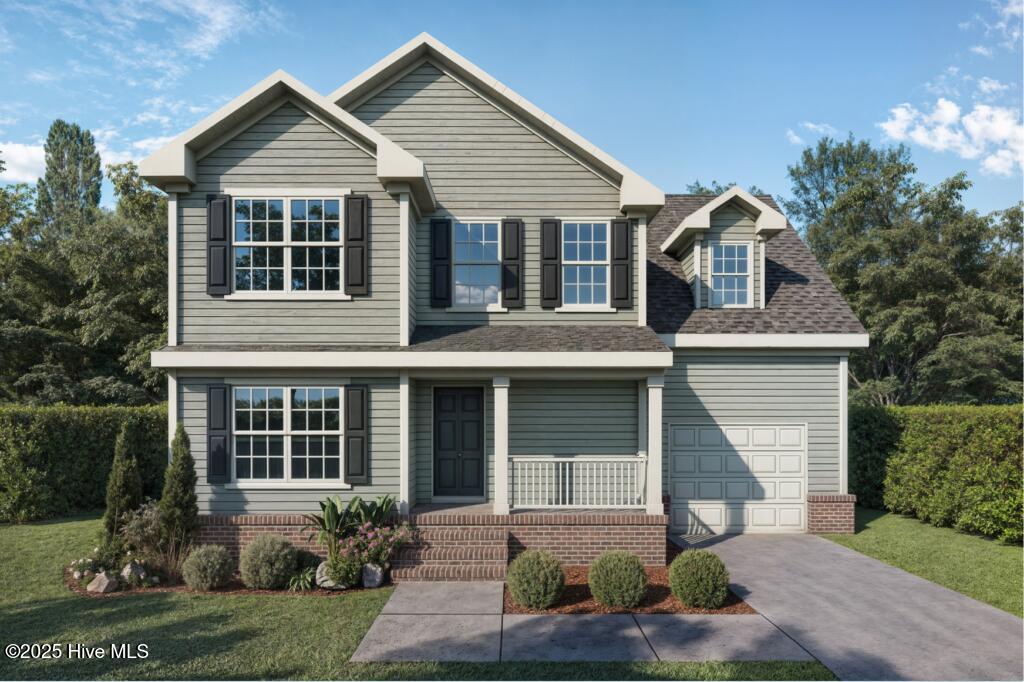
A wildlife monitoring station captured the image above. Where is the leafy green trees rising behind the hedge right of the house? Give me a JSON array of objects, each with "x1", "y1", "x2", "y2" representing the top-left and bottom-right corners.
[{"x1": 785, "y1": 137, "x2": 1024, "y2": 404}]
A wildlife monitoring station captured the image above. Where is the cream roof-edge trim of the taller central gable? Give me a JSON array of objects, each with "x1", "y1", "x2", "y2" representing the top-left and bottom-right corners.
[{"x1": 329, "y1": 33, "x2": 665, "y2": 215}]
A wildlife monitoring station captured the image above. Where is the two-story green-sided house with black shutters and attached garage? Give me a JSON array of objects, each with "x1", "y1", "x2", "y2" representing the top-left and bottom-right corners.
[{"x1": 141, "y1": 34, "x2": 867, "y2": 579}]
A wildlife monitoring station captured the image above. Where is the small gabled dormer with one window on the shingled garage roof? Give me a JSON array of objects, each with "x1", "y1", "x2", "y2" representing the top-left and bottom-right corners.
[{"x1": 660, "y1": 186, "x2": 786, "y2": 308}]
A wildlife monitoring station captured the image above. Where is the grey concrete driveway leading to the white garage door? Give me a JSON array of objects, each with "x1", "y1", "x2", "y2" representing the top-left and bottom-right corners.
[{"x1": 698, "y1": 535, "x2": 1024, "y2": 680}]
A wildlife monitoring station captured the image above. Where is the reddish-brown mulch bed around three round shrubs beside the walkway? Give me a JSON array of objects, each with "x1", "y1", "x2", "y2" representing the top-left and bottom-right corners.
[{"x1": 504, "y1": 542, "x2": 757, "y2": 614}]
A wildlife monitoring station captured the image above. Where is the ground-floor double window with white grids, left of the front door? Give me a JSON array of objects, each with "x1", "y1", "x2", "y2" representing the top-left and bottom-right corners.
[{"x1": 232, "y1": 386, "x2": 342, "y2": 483}]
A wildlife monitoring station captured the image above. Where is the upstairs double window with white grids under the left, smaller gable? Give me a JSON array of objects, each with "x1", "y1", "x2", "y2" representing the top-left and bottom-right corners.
[{"x1": 233, "y1": 198, "x2": 343, "y2": 297}]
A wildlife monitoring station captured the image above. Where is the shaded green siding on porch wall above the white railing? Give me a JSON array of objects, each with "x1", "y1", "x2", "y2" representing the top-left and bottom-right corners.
[{"x1": 509, "y1": 379, "x2": 638, "y2": 455}]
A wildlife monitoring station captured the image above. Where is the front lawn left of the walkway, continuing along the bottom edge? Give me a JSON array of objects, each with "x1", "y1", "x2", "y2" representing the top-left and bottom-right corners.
[{"x1": 0, "y1": 518, "x2": 834, "y2": 680}]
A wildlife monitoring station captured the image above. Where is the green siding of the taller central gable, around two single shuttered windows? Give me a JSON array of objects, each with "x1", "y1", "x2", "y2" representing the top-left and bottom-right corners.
[{"x1": 353, "y1": 62, "x2": 641, "y2": 325}]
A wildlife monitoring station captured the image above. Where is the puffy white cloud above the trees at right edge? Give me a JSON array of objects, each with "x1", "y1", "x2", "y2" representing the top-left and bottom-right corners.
[{"x1": 878, "y1": 97, "x2": 1024, "y2": 175}]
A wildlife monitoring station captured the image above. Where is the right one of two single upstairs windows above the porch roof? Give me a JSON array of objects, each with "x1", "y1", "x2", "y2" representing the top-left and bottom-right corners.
[{"x1": 562, "y1": 221, "x2": 609, "y2": 306}]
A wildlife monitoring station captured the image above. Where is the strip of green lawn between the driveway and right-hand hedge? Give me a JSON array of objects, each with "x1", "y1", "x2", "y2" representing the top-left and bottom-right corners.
[{"x1": 825, "y1": 507, "x2": 1024, "y2": 616}]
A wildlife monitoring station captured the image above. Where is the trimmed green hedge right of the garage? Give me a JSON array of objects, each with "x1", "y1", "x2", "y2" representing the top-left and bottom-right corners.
[{"x1": 850, "y1": 406, "x2": 1024, "y2": 543}]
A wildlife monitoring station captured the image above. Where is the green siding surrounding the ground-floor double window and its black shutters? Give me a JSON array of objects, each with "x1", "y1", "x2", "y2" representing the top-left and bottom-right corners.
[{"x1": 178, "y1": 373, "x2": 399, "y2": 514}]
